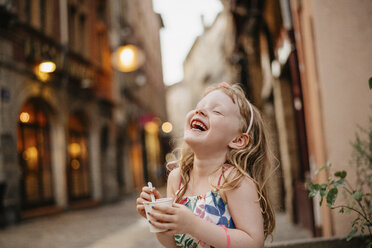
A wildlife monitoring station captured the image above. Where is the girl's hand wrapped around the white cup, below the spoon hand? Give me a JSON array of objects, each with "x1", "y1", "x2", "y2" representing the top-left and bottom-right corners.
[{"x1": 148, "y1": 203, "x2": 199, "y2": 235}]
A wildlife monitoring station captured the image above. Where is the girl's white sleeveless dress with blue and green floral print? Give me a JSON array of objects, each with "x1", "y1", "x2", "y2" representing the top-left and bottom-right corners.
[{"x1": 174, "y1": 169, "x2": 235, "y2": 248}]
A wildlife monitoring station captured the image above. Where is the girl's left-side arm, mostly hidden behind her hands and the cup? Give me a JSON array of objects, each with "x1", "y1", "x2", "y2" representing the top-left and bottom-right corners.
[{"x1": 156, "y1": 168, "x2": 180, "y2": 247}]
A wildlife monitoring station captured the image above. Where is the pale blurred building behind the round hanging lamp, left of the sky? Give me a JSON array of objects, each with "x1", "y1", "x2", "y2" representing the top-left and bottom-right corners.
[{"x1": 110, "y1": 0, "x2": 170, "y2": 189}]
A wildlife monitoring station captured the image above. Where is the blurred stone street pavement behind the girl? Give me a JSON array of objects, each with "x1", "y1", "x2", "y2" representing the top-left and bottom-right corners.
[{"x1": 0, "y1": 196, "x2": 311, "y2": 248}]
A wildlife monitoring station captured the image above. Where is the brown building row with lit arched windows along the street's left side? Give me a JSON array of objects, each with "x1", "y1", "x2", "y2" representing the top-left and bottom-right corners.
[{"x1": 0, "y1": 0, "x2": 166, "y2": 225}]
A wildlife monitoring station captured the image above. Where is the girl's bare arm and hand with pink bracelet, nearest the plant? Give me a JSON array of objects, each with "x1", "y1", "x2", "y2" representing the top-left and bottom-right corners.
[{"x1": 153, "y1": 178, "x2": 264, "y2": 248}]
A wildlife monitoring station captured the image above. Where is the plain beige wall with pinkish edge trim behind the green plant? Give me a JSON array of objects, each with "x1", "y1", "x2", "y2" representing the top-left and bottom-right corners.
[{"x1": 289, "y1": 0, "x2": 372, "y2": 236}]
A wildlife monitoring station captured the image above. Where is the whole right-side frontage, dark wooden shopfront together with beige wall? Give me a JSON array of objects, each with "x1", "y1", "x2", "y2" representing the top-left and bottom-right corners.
[{"x1": 224, "y1": 0, "x2": 372, "y2": 236}]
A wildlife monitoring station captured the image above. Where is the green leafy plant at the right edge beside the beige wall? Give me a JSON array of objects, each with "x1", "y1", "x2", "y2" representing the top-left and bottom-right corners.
[{"x1": 306, "y1": 118, "x2": 372, "y2": 248}]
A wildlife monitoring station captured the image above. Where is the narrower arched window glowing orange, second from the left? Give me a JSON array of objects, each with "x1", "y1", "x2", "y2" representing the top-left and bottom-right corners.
[{"x1": 67, "y1": 114, "x2": 90, "y2": 201}]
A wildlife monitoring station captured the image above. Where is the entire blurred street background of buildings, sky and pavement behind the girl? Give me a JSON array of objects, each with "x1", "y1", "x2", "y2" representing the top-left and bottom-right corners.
[{"x1": 0, "y1": 0, "x2": 372, "y2": 247}]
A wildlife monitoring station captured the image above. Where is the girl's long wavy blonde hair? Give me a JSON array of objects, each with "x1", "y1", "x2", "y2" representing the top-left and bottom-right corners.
[{"x1": 168, "y1": 84, "x2": 275, "y2": 239}]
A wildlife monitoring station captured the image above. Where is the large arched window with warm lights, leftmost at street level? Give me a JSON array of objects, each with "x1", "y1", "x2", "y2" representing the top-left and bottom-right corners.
[{"x1": 18, "y1": 99, "x2": 54, "y2": 209}]
